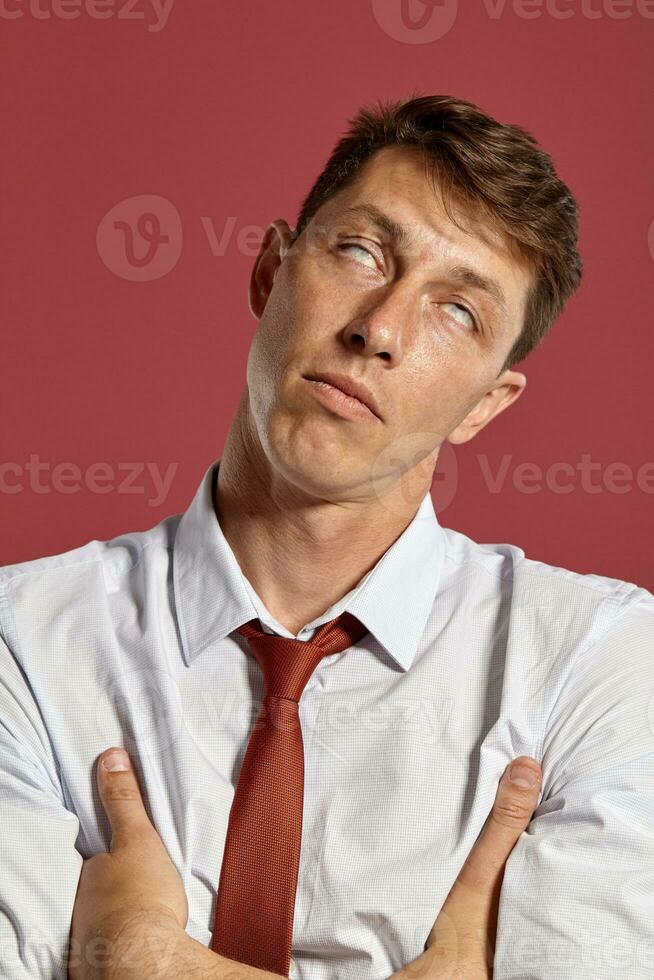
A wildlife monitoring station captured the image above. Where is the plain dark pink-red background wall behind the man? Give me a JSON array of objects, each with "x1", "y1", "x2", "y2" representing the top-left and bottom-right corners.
[{"x1": 0, "y1": 0, "x2": 654, "y2": 590}]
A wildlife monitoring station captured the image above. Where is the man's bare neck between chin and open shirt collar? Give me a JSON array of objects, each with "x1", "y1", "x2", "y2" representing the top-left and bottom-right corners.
[{"x1": 214, "y1": 390, "x2": 429, "y2": 635}]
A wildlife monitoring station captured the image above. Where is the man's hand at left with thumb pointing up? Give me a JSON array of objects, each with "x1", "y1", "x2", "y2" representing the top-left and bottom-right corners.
[{"x1": 68, "y1": 749, "x2": 188, "y2": 980}]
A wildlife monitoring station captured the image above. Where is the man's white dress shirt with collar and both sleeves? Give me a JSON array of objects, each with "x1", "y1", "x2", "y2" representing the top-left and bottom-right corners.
[{"x1": 0, "y1": 460, "x2": 654, "y2": 980}]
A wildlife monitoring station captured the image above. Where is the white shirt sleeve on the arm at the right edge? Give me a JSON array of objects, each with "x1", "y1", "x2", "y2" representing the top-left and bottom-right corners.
[{"x1": 493, "y1": 590, "x2": 654, "y2": 980}]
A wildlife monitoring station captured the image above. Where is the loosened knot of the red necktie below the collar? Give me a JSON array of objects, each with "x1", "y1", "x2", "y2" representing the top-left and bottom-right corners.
[{"x1": 236, "y1": 612, "x2": 368, "y2": 702}]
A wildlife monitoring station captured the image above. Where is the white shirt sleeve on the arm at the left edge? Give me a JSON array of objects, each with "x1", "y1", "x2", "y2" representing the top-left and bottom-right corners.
[{"x1": 0, "y1": 637, "x2": 83, "y2": 980}]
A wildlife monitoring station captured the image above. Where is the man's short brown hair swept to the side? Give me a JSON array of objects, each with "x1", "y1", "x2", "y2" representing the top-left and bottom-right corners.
[{"x1": 295, "y1": 95, "x2": 582, "y2": 374}]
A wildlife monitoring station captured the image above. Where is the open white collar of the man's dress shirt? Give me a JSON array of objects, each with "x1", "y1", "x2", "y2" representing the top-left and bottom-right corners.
[{"x1": 173, "y1": 460, "x2": 445, "y2": 670}]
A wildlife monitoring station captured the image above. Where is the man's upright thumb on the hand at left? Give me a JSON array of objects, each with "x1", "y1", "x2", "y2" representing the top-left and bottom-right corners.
[{"x1": 97, "y1": 748, "x2": 152, "y2": 852}]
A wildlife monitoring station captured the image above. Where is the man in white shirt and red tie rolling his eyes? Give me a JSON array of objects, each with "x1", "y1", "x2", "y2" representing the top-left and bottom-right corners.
[{"x1": 0, "y1": 96, "x2": 654, "y2": 980}]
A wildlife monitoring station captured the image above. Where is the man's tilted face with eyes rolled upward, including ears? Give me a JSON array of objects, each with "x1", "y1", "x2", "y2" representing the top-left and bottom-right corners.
[{"x1": 247, "y1": 147, "x2": 530, "y2": 499}]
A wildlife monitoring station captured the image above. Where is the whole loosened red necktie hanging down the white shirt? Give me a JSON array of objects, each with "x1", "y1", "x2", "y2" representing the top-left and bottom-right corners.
[{"x1": 211, "y1": 613, "x2": 368, "y2": 977}]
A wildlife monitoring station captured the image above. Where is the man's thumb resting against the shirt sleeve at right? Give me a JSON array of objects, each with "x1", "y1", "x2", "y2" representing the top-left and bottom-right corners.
[{"x1": 459, "y1": 755, "x2": 542, "y2": 890}]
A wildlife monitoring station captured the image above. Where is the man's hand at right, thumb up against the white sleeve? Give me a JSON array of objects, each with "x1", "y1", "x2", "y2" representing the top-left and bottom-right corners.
[{"x1": 420, "y1": 755, "x2": 542, "y2": 980}]
